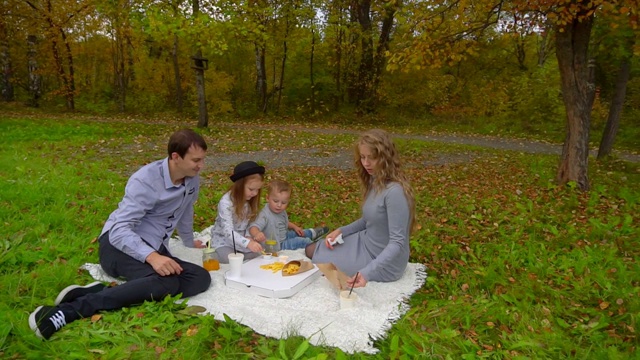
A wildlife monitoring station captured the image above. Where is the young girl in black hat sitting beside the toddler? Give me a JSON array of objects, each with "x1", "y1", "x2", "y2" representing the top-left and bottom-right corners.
[{"x1": 211, "y1": 161, "x2": 265, "y2": 264}]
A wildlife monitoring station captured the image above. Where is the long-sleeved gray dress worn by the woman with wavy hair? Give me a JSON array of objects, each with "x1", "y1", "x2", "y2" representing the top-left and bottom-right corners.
[{"x1": 313, "y1": 183, "x2": 410, "y2": 282}]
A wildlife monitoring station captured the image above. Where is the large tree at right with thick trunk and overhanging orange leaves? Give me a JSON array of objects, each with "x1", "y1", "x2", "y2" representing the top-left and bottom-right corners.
[{"x1": 391, "y1": 0, "x2": 638, "y2": 190}]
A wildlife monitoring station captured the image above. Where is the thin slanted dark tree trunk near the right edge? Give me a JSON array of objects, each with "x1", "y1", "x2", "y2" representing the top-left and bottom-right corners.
[{"x1": 598, "y1": 58, "x2": 631, "y2": 159}]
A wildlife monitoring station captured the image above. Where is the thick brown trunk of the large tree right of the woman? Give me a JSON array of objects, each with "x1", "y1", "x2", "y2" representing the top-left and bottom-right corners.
[{"x1": 556, "y1": 15, "x2": 595, "y2": 191}]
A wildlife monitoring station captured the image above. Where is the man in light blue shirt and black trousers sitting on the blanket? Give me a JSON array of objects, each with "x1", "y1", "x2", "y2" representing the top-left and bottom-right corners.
[{"x1": 29, "y1": 130, "x2": 211, "y2": 339}]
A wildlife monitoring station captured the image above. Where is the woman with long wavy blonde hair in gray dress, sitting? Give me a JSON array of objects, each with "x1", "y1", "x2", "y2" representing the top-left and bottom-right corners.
[{"x1": 305, "y1": 129, "x2": 415, "y2": 287}]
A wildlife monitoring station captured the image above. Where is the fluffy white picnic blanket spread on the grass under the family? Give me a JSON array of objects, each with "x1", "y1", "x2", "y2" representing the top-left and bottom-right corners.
[{"x1": 82, "y1": 233, "x2": 427, "y2": 354}]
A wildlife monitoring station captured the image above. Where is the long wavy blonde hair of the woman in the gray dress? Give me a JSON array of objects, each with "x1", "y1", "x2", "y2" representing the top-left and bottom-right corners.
[{"x1": 354, "y1": 129, "x2": 415, "y2": 231}]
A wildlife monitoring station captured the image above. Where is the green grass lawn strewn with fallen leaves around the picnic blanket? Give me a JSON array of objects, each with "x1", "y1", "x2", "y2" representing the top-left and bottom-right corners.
[{"x1": 0, "y1": 115, "x2": 640, "y2": 359}]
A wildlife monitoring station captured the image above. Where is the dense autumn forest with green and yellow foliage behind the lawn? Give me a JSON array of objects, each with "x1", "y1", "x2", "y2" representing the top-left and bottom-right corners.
[{"x1": 0, "y1": 0, "x2": 640, "y2": 155}]
